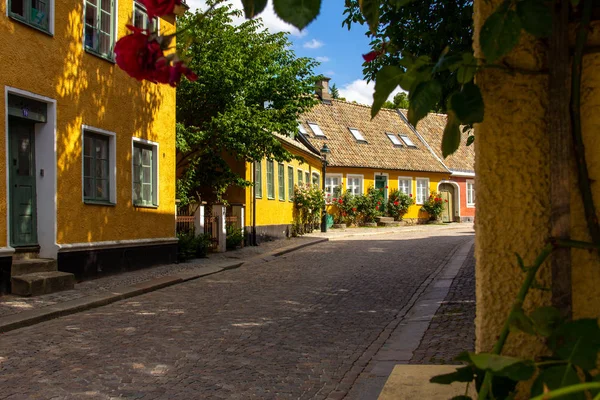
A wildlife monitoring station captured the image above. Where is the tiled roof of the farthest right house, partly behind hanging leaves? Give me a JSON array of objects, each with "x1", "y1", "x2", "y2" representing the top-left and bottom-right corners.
[{"x1": 400, "y1": 109, "x2": 475, "y2": 172}]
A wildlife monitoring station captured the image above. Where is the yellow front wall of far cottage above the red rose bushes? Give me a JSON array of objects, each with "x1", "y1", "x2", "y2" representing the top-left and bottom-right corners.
[{"x1": 327, "y1": 167, "x2": 450, "y2": 219}]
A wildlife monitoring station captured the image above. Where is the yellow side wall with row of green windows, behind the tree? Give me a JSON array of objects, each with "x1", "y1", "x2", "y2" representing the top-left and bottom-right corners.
[{"x1": 245, "y1": 143, "x2": 322, "y2": 227}]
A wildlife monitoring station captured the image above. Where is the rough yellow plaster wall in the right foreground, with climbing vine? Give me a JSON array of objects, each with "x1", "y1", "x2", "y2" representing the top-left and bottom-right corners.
[{"x1": 475, "y1": 0, "x2": 600, "y2": 355}]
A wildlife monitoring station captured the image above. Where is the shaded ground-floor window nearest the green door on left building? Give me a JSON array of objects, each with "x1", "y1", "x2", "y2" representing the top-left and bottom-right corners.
[{"x1": 83, "y1": 132, "x2": 110, "y2": 201}]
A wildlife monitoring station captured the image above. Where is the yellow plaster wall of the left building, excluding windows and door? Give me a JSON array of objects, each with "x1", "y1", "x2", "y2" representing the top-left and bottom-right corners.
[{"x1": 0, "y1": 0, "x2": 175, "y2": 243}]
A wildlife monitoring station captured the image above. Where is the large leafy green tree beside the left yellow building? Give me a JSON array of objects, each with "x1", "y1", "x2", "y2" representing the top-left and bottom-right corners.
[{"x1": 177, "y1": 0, "x2": 317, "y2": 203}]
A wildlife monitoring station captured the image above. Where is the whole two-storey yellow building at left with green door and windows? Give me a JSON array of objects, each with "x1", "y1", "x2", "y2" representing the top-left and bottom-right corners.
[{"x1": 0, "y1": 0, "x2": 177, "y2": 288}]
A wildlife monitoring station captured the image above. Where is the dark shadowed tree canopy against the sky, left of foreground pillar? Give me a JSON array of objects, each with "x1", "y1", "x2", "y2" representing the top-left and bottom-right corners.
[{"x1": 342, "y1": 0, "x2": 473, "y2": 111}]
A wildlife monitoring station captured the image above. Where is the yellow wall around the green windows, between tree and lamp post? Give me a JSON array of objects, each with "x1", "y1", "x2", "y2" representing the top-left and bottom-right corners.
[{"x1": 245, "y1": 145, "x2": 322, "y2": 226}]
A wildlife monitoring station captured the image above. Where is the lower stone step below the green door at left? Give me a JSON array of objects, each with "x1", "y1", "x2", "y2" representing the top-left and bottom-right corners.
[{"x1": 11, "y1": 271, "x2": 75, "y2": 296}]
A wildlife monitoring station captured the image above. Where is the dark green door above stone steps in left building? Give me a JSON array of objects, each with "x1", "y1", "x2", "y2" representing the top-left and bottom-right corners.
[{"x1": 8, "y1": 118, "x2": 37, "y2": 247}]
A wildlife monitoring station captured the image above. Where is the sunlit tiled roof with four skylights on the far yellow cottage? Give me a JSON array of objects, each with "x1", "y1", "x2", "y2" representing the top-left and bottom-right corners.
[{"x1": 299, "y1": 100, "x2": 448, "y2": 172}]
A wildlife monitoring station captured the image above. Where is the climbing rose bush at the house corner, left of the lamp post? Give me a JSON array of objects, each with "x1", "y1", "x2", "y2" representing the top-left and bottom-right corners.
[{"x1": 293, "y1": 184, "x2": 325, "y2": 236}]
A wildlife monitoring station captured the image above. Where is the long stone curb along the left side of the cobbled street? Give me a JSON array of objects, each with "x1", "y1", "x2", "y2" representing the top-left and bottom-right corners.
[{"x1": 0, "y1": 238, "x2": 329, "y2": 334}]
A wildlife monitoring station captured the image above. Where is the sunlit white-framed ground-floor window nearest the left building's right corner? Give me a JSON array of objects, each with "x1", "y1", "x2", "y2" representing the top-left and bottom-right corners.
[{"x1": 133, "y1": 138, "x2": 158, "y2": 206}]
